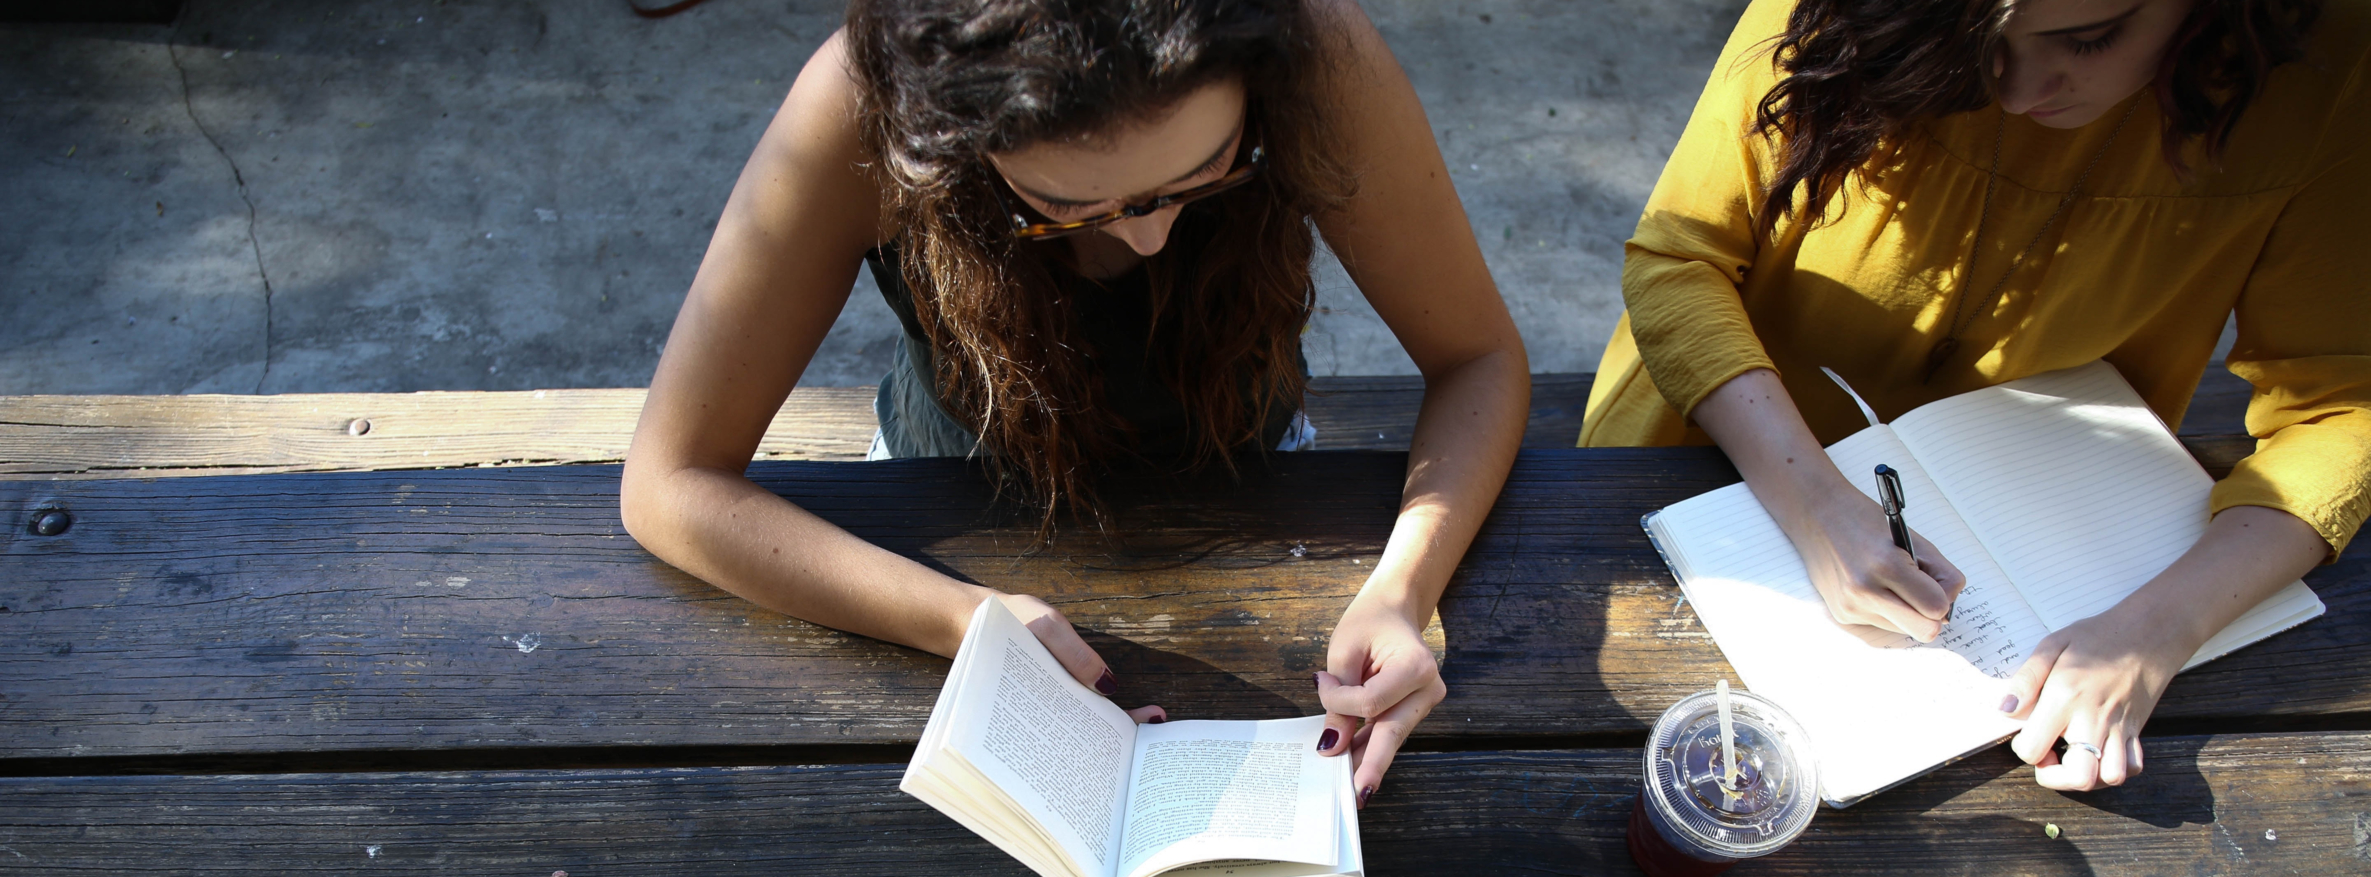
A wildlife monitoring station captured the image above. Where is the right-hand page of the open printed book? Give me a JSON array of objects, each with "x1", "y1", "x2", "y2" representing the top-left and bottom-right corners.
[{"x1": 1119, "y1": 716, "x2": 1349, "y2": 877}]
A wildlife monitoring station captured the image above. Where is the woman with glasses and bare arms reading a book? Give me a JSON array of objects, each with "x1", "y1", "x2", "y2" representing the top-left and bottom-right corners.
[{"x1": 621, "y1": 0, "x2": 1529, "y2": 804}]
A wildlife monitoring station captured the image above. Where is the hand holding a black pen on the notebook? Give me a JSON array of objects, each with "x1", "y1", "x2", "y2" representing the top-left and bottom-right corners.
[{"x1": 1783, "y1": 486, "x2": 1968, "y2": 642}]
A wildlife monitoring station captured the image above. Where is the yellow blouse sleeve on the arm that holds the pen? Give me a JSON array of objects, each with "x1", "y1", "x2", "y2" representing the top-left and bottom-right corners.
[{"x1": 1622, "y1": 0, "x2": 1790, "y2": 415}]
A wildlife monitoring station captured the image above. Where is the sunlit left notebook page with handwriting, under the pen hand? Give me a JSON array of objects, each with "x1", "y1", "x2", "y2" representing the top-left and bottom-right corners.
[{"x1": 1650, "y1": 427, "x2": 2039, "y2": 801}]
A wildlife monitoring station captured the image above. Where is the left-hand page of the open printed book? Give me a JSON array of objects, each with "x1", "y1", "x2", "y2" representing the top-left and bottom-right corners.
[{"x1": 944, "y1": 600, "x2": 1136, "y2": 875}]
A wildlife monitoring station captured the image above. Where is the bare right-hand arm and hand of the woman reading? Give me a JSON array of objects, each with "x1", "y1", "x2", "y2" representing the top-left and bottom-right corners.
[{"x1": 1318, "y1": 2, "x2": 1532, "y2": 801}]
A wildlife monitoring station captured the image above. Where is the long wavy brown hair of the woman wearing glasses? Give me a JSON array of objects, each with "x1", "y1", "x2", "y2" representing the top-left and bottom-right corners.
[{"x1": 846, "y1": 0, "x2": 1351, "y2": 533}]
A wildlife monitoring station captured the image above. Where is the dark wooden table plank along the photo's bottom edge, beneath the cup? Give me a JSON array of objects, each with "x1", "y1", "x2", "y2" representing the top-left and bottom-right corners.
[{"x1": 0, "y1": 735, "x2": 2371, "y2": 877}]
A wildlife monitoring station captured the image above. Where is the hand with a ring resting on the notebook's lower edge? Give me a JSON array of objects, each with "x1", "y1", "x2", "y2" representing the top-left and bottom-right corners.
[{"x1": 2001, "y1": 607, "x2": 2191, "y2": 792}]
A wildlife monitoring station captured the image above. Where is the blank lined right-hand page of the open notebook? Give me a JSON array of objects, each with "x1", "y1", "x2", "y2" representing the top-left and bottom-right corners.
[{"x1": 1892, "y1": 363, "x2": 2215, "y2": 630}]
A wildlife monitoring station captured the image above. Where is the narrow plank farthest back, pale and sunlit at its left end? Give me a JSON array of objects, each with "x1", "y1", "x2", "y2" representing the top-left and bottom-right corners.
[{"x1": 0, "y1": 370, "x2": 2255, "y2": 479}]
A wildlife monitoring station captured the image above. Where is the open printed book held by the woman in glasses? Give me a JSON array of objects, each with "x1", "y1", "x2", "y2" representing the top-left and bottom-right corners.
[{"x1": 899, "y1": 600, "x2": 1363, "y2": 877}]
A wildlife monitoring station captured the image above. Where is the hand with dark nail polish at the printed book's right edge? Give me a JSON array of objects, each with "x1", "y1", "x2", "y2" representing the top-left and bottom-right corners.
[{"x1": 1318, "y1": 593, "x2": 1449, "y2": 808}]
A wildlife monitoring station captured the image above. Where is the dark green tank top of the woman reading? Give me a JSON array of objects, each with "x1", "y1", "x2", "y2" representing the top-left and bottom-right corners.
[{"x1": 865, "y1": 242, "x2": 1309, "y2": 460}]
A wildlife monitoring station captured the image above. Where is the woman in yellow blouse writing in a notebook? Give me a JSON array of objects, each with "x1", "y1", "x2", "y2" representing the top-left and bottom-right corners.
[{"x1": 1581, "y1": 0, "x2": 2371, "y2": 789}]
